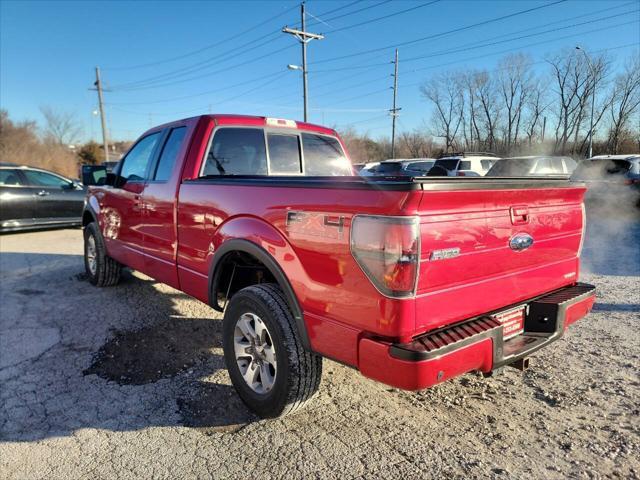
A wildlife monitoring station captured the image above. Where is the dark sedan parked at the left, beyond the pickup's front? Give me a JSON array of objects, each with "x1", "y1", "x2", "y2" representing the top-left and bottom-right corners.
[{"x1": 0, "y1": 165, "x2": 86, "y2": 232}]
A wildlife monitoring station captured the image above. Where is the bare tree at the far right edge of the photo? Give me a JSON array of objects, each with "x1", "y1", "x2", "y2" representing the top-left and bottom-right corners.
[{"x1": 607, "y1": 55, "x2": 640, "y2": 153}]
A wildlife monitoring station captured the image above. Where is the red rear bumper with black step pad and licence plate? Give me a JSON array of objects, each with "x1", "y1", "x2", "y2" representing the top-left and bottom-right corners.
[{"x1": 358, "y1": 283, "x2": 596, "y2": 390}]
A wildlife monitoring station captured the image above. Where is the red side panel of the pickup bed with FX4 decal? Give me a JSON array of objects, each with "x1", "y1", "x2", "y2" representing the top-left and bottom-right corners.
[{"x1": 178, "y1": 180, "x2": 419, "y2": 364}]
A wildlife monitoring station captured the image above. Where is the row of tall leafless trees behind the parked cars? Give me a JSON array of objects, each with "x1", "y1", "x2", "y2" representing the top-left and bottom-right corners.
[{"x1": 341, "y1": 49, "x2": 640, "y2": 161}]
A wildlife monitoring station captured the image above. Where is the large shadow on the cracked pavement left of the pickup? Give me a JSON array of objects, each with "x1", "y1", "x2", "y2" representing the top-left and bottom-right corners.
[{"x1": 0, "y1": 252, "x2": 257, "y2": 441}]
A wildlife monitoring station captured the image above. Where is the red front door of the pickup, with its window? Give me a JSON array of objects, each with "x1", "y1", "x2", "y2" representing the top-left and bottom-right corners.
[{"x1": 101, "y1": 131, "x2": 163, "y2": 273}]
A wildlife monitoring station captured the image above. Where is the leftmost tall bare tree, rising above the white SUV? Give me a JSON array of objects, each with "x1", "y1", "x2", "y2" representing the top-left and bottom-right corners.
[{"x1": 420, "y1": 72, "x2": 464, "y2": 150}]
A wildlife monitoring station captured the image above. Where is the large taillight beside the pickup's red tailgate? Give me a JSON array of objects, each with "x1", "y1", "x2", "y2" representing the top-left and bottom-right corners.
[{"x1": 351, "y1": 215, "x2": 420, "y2": 298}]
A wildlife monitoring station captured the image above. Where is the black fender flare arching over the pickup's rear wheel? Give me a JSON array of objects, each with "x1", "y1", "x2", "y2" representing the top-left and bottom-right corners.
[{"x1": 209, "y1": 238, "x2": 311, "y2": 350}]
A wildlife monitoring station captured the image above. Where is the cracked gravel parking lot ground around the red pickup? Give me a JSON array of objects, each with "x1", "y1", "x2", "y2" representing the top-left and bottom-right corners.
[{"x1": 0, "y1": 219, "x2": 640, "y2": 479}]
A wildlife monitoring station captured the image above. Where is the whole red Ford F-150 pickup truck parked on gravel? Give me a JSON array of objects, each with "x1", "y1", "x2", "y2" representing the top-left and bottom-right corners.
[{"x1": 83, "y1": 115, "x2": 595, "y2": 417}]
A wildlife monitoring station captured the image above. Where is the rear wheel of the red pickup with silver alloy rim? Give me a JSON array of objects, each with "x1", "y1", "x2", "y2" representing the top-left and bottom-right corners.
[{"x1": 222, "y1": 284, "x2": 322, "y2": 418}]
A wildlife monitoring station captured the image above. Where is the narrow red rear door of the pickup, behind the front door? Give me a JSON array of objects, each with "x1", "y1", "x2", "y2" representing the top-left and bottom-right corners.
[{"x1": 141, "y1": 124, "x2": 189, "y2": 288}]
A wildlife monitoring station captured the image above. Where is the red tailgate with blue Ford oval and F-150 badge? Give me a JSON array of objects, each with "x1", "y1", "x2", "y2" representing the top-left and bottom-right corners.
[{"x1": 416, "y1": 181, "x2": 585, "y2": 331}]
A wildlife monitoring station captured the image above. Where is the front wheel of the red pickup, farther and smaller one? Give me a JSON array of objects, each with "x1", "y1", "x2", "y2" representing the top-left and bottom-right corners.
[{"x1": 84, "y1": 222, "x2": 122, "y2": 287}]
